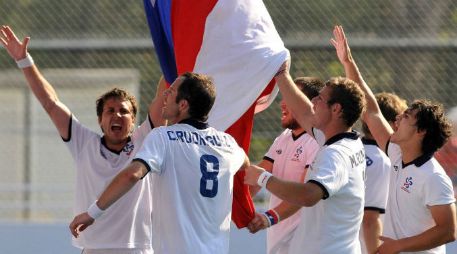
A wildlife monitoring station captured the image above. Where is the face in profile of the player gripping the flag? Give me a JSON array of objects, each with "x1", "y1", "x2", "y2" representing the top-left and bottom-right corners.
[{"x1": 312, "y1": 86, "x2": 332, "y2": 130}]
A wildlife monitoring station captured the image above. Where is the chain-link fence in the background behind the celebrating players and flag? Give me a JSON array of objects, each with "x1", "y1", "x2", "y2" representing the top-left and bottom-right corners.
[{"x1": 0, "y1": 0, "x2": 457, "y2": 222}]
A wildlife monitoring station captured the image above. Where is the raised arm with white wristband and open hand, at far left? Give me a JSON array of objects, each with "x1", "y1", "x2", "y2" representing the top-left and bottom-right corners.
[{"x1": 0, "y1": 26, "x2": 71, "y2": 139}]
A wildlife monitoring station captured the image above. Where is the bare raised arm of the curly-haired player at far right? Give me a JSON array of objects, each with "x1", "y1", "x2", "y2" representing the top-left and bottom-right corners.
[{"x1": 330, "y1": 26, "x2": 393, "y2": 149}]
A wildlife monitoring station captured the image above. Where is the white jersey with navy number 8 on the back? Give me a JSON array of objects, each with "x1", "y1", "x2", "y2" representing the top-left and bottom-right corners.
[{"x1": 135, "y1": 120, "x2": 246, "y2": 254}]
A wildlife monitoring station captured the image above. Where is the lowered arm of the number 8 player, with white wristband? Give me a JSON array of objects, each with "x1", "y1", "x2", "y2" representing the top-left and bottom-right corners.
[{"x1": 69, "y1": 161, "x2": 148, "y2": 237}]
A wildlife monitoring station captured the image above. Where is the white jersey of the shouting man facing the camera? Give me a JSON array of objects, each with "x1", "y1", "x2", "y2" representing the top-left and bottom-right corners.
[{"x1": 66, "y1": 117, "x2": 152, "y2": 249}]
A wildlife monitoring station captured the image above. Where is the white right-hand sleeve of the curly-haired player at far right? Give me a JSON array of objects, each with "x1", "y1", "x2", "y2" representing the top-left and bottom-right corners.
[{"x1": 424, "y1": 172, "x2": 455, "y2": 206}]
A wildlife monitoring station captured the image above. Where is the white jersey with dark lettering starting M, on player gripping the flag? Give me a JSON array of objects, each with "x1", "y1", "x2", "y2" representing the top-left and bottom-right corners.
[{"x1": 290, "y1": 129, "x2": 366, "y2": 254}]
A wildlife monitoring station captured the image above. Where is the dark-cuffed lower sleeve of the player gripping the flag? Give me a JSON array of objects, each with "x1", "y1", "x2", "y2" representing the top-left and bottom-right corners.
[{"x1": 307, "y1": 147, "x2": 349, "y2": 197}]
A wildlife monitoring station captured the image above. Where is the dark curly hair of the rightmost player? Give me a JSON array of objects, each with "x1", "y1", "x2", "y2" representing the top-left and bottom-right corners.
[{"x1": 410, "y1": 100, "x2": 452, "y2": 154}]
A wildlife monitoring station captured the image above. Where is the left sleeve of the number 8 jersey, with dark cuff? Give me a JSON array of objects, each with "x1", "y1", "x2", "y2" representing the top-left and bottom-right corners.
[{"x1": 134, "y1": 128, "x2": 168, "y2": 174}]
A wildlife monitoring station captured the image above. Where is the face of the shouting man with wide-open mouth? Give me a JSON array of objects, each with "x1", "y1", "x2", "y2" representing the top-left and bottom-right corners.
[{"x1": 98, "y1": 98, "x2": 135, "y2": 146}]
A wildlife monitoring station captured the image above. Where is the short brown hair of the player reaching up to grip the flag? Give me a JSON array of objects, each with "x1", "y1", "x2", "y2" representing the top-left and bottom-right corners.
[{"x1": 325, "y1": 77, "x2": 366, "y2": 127}]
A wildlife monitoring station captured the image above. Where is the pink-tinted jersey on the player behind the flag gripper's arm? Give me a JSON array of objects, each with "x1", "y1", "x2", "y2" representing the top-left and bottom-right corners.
[{"x1": 263, "y1": 129, "x2": 319, "y2": 254}]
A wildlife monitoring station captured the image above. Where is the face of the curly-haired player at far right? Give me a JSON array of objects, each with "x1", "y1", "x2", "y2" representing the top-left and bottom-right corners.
[{"x1": 390, "y1": 109, "x2": 418, "y2": 144}]
